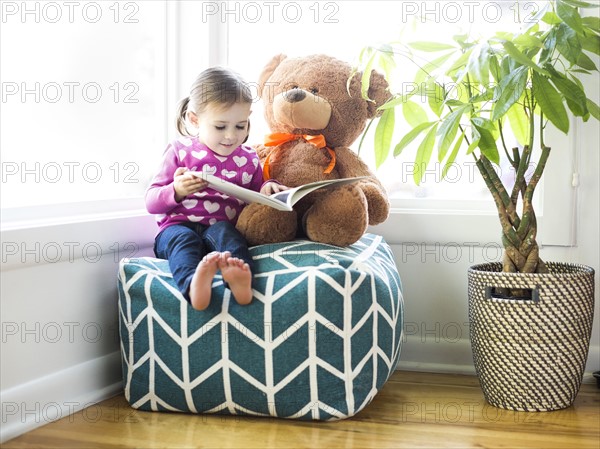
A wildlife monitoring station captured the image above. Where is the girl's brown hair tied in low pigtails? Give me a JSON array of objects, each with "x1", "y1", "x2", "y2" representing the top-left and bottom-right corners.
[{"x1": 176, "y1": 67, "x2": 252, "y2": 136}]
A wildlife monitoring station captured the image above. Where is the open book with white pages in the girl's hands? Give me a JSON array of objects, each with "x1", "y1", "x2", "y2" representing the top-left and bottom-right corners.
[{"x1": 187, "y1": 171, "x2": 364, "y2": 211}]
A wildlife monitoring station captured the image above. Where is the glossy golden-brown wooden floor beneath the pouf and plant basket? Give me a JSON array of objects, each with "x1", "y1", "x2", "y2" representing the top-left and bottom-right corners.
[{"x1": 2, "y1": 372, "x2": 600, "y2": 449}]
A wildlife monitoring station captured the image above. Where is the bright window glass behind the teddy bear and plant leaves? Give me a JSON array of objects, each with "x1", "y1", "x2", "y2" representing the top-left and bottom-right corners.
[{"x1": 220, "y1": 1, "x2": 552, "y2": 211}]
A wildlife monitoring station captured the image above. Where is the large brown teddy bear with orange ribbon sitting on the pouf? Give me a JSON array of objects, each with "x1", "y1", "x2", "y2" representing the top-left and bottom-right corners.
[{"x1": 237, "y1": 55, "x2": 390, "y2": 246}]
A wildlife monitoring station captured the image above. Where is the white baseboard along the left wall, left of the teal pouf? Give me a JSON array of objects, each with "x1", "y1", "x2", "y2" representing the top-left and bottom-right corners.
[{"x1": 0, "y1": 351, "x2": 123, "y2": 443}]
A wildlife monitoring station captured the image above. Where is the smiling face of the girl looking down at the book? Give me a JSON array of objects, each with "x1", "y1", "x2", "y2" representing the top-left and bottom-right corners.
[{"x1": 189, "y1": 103, "x2": 251, "y2": 156}]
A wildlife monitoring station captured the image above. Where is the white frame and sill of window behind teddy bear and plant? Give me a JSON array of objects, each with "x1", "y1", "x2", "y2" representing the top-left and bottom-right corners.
[{"x1": 209, "y1": 1, "x2": 580, "y2": 248}]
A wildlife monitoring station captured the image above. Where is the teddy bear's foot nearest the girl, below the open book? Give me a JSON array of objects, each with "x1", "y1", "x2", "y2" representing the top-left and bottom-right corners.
[{"x1": 236, "y1": 204, "x2": 298, "y2": 246}]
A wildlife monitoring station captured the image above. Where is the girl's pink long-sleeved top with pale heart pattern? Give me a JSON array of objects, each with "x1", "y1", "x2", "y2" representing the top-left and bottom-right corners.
[{"x1": 146, "y1": 137, "x2": 263, "y2": 232}]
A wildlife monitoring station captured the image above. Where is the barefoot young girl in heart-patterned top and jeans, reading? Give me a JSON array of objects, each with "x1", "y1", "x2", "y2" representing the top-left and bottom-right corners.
[{"x1": 146, "y1": 68, "x2": 286, "y2": 310}]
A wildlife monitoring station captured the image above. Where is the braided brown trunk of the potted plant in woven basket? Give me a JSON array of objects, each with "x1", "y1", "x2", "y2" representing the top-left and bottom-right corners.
[{"x1": 476, "y1": 145, "x2": 550, "y2": 284}]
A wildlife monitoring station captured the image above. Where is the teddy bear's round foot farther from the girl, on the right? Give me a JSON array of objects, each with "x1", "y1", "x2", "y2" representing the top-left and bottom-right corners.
[{"x1": 303, "y1": 186, "x2": 368, "y2": 246}]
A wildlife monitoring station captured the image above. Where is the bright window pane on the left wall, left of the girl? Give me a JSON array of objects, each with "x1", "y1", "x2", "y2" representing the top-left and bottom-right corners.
[{"x1": 0, "y1": 1, "x2": 167, "y2": 215}]
